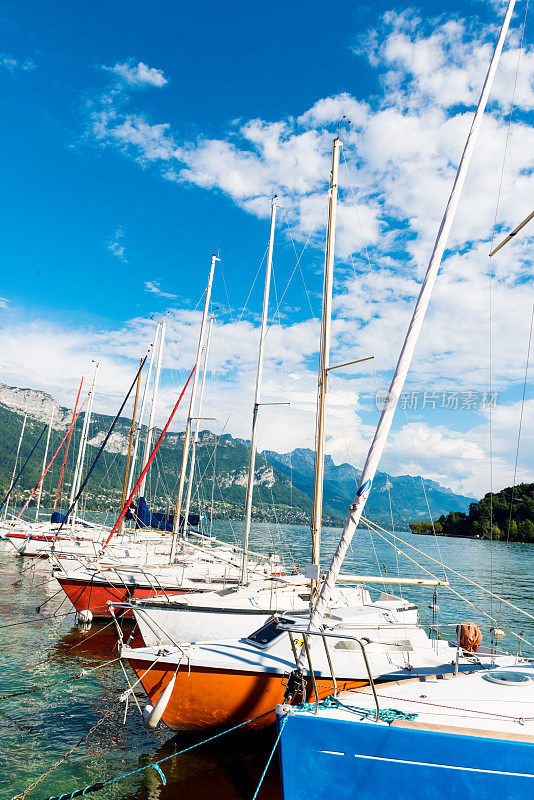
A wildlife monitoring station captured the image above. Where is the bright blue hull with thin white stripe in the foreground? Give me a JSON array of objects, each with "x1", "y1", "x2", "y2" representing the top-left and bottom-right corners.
[{"x1": 278, "y1": 712, "x2": 534, "y2": 800}]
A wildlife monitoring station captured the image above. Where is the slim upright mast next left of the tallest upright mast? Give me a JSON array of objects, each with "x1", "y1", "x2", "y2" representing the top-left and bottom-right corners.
[{"x1": 240, "y1": 203, "x2": 278, "y2": 583}]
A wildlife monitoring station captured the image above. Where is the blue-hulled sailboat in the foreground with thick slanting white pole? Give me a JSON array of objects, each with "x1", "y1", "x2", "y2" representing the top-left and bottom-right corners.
[{"x1": 278, "y1": 0, "x2": 534, "y2": 800}]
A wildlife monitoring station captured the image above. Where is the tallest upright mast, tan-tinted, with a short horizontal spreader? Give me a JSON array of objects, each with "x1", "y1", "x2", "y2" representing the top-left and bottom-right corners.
[{"x1": 311, "y1": 136, "x2": 341, "y2": 602}]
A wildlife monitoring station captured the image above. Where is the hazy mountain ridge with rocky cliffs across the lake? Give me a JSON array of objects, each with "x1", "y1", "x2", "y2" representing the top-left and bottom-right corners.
[{"x1": 0, "y1": 383, "x2": 472, "y2": 528}]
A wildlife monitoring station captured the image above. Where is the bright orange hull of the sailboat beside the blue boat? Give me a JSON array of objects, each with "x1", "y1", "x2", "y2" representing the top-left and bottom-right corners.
[{"x1": 128, "y1": 659, "x2": 366, "y2": 732}]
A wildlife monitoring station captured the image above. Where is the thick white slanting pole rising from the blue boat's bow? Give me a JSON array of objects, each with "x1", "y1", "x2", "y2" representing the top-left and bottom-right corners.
[{"x1": 306, "y1": 0, "x2": 515, "y2": 640}]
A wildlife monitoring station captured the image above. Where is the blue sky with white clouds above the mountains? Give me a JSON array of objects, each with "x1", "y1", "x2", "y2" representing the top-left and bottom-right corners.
[{"x1": 0, "y1": 2, "x2": 534, "y2": 494}]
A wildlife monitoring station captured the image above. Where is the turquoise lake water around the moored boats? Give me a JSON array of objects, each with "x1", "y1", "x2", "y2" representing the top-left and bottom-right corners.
[{"x1": 0, "y1": 522, "x2": 534, "y2": 800}]
